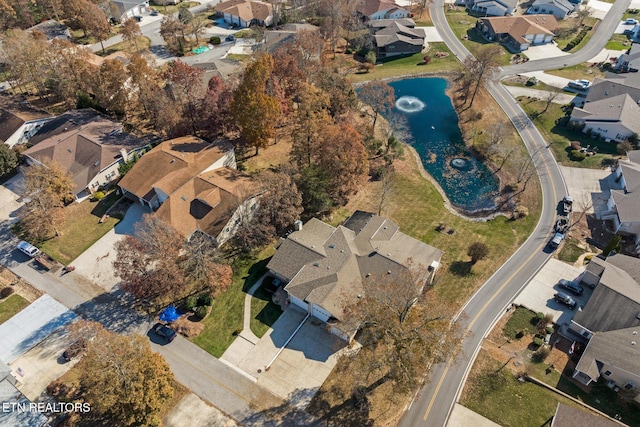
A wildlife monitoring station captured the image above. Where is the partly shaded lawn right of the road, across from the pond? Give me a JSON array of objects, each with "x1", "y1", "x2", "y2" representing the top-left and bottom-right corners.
[{"x1": 518, "y1": 97, "x2": 616, "y2": 169}]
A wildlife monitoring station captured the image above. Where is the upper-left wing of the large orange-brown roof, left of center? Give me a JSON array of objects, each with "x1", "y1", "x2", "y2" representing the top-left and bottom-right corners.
[{"x1": 119, "y1": 136, "x2": 233, "y2": 201}]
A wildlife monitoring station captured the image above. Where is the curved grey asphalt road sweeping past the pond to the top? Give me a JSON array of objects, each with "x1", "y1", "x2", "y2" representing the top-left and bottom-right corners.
[{"x1": 400, "y1": 0, "x2": 630, "y2": 427}]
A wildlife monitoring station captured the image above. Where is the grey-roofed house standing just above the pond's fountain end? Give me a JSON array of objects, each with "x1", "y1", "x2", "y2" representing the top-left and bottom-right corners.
[{"x1": 371, "y1": 18, "x2": 428, "y2": 58}]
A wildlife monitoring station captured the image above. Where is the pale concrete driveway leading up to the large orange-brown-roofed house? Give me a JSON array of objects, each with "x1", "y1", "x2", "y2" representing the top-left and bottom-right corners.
[{"x1": 70, "y1": 203, "x2": 146, "y2": 292}]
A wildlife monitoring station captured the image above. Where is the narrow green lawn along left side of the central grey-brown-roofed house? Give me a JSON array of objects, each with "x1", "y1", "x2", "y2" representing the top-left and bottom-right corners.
[{"x1": 193, "y1": 246, "x2": 275, "y2": 357}]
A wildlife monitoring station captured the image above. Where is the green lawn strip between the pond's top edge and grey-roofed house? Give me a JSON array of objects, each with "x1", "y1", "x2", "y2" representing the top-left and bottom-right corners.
[{"x1": 349, "y1": 43, "x2": 461, "y2": 82}]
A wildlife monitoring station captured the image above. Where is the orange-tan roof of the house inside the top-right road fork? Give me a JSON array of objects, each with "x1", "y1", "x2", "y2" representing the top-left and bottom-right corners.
[{"x1": 481, "y1": 15, "x2": 558, "y2": 43}]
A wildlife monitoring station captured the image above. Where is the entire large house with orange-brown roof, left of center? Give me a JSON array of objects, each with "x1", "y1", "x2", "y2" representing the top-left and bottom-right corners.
[{"x1": 119, "y1": 136, "x2": 259, "y2": 244}]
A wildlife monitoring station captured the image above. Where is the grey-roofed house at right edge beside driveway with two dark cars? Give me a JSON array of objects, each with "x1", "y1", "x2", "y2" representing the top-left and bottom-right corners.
[{"x1": 569, "y1": 255, "x2": 640, "y2": 391}]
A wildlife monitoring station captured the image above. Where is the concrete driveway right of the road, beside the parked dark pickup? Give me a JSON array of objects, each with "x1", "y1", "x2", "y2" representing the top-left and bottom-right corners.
[{"x1": 559, "y1": 166, "x2": 620, "y2": 216}]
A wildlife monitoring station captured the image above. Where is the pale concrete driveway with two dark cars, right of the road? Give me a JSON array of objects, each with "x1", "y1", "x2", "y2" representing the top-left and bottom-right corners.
[{"x1": 514, "y1": 258, "x2": 591, "y2": 325}]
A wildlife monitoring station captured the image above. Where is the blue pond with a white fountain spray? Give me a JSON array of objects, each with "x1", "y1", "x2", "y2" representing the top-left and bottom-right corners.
[{"x1": 389, "y1": 78, "x2": 499, "y2": 212}]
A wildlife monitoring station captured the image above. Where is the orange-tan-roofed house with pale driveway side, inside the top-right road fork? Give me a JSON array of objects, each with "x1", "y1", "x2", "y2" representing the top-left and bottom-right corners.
[{"x1": 476, "y1": 15, "x2": 558, "y2": 52}]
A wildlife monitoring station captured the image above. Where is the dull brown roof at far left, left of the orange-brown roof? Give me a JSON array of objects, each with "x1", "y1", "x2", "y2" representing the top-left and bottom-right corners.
[{"x1": 24, "y1": 116, "x2": 144, "y2": 193}]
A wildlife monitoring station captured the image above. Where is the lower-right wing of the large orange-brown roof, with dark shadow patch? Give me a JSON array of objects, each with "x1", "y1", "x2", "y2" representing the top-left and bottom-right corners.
[{"x1": 156, "y1": 167, "x2": 255, "y2": 241}]
